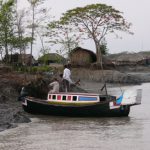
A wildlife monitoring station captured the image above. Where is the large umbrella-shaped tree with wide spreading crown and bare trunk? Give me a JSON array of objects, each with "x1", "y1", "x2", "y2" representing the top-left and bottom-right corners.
[{"x1": 60, "y1": 4, "x2": 131, "y2": 64}]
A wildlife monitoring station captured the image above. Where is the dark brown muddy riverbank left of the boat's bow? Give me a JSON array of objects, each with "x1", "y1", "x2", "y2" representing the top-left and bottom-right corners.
[{"x1": 0, "y1": 71, "x2": 30, "y2": 131}]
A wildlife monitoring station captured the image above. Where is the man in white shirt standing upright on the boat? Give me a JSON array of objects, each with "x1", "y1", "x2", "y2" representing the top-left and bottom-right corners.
[{"x1": 63, "y1": 65, "x2": 73, "y2": 92}]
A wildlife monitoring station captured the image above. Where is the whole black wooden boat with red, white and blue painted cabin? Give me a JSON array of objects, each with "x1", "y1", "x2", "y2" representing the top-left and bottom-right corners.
[{"x1": 22, "y1": 89, "x2": 142, "y2": 117}]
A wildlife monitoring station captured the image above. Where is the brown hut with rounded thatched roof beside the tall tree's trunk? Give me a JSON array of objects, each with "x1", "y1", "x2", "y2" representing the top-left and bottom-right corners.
[{"x1": 70, "y1": 47, "x2": 96, "y2": 67}]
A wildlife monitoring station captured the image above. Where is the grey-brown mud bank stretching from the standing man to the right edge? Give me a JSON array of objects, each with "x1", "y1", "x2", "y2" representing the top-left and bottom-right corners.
[{"x1": 72, "y1": 68, "x2": 150, "y2": 84}]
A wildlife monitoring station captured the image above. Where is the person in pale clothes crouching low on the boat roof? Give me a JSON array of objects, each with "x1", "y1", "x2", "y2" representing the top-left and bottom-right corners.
[{"x1": 48, "y1": 78, "x2": 59, "y2": 93}]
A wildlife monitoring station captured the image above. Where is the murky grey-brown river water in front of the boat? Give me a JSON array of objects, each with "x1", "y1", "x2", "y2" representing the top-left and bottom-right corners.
[{"x1": 0, "y1": 83, "x2": 150, "y2": 150}]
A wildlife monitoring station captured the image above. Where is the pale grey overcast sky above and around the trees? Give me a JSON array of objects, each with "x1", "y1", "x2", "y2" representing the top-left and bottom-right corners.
[{"x1": 18, "y1": 0, "x2": 150, "y2": 56}]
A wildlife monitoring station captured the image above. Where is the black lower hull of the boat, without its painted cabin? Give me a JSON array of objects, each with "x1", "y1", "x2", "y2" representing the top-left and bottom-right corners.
[{"x1": 22, "y1": 98, "x2": 130, "y2": 117}]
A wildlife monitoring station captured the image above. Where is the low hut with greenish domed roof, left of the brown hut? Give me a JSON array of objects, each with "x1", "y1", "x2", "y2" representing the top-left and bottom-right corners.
[{"x1": 38, "y1": 53, "x2": 66, "y2": 65}]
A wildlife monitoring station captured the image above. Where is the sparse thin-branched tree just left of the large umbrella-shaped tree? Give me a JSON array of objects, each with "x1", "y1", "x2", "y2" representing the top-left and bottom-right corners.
[{"x1": 46, "y1": 21, "x2": 81, "y2": 56}]
